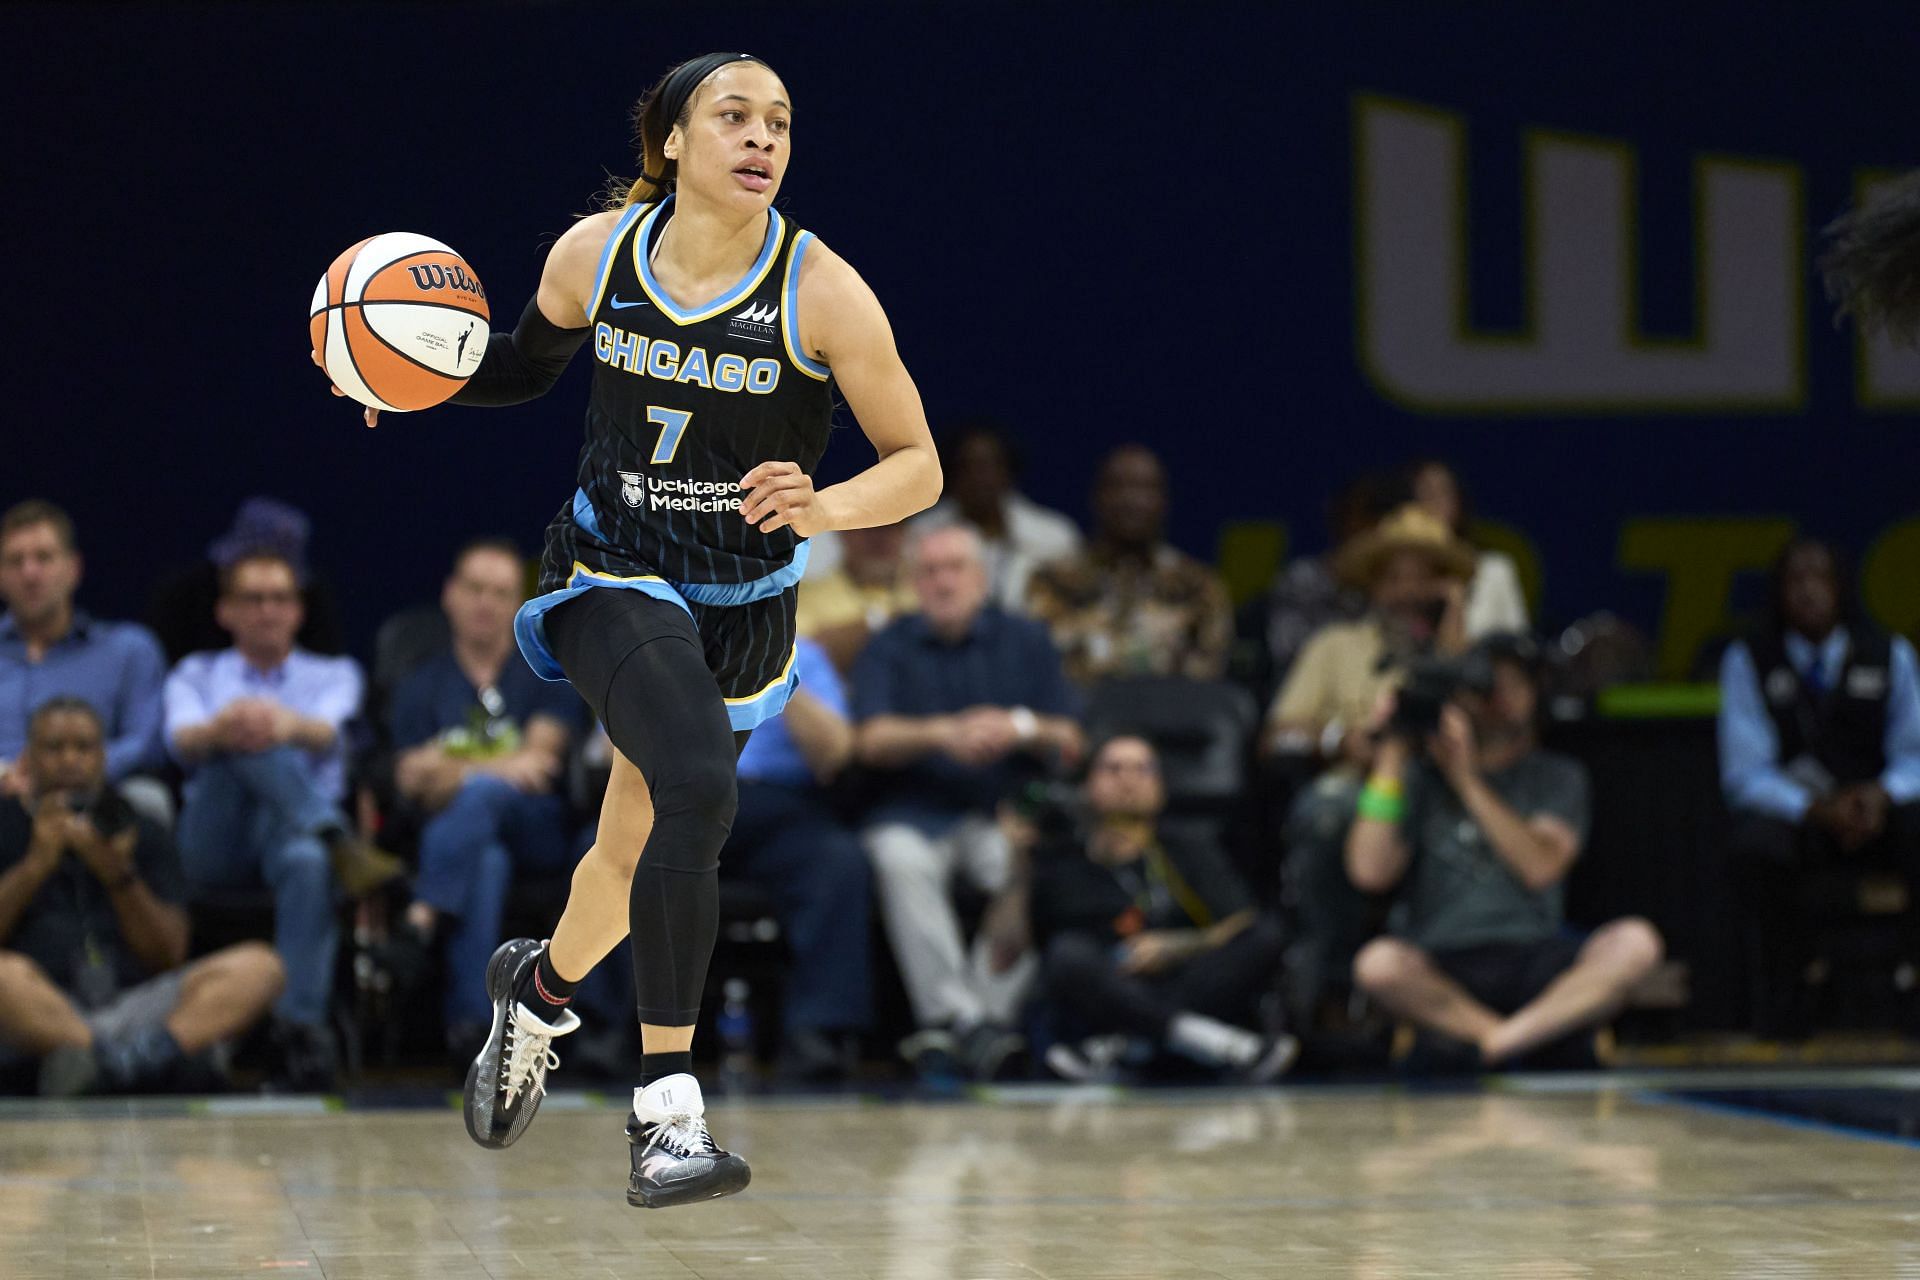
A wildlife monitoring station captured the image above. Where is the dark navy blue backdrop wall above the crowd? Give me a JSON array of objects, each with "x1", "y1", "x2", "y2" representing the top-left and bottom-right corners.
[{"x1": 0, "y1": 2, "x2": 1920, "y2": 660}]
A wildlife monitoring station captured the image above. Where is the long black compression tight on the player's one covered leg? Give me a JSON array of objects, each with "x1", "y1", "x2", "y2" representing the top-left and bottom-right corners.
[{"x1": 547, "y1": 589, "x2": 745, "y2": 1027}]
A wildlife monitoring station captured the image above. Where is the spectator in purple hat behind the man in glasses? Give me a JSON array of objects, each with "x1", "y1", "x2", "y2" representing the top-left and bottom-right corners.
[{"x1": 146, "y1": 497, "x2": 346, "y2": 662}]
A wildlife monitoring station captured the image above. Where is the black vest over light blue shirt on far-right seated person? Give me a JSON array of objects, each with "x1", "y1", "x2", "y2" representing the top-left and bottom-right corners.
[{"x1": 1749, "y1": 626, "x2": 1893, "y2": 787}]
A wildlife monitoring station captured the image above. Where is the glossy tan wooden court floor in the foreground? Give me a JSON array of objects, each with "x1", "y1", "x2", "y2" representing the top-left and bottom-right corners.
[{"x1": 0, "y1": 1071, "x2": 1920, "y2": 1280}]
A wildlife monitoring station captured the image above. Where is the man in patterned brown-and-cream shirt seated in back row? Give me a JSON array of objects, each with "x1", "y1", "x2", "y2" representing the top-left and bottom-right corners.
[{"x1": 1027, "y1": 445, "x2": 1233, "y2": 685}]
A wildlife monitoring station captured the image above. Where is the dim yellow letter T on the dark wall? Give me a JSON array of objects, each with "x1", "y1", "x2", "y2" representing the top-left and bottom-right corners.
[{"x1": 1620, "y1": 516, "x2": 1793, "y2": 679}]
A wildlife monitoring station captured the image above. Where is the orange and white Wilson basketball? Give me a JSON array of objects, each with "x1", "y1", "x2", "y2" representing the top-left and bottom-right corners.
[{"x1": 307, "y1": 230, "x2": 488, "y2": 411}]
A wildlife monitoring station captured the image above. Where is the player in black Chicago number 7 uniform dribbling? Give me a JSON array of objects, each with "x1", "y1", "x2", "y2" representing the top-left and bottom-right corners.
[{"x1": 320, "y1": 54, "x2": 941, "y2": 1207}]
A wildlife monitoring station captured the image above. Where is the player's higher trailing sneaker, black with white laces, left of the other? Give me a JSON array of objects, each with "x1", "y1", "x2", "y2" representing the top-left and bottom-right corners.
[{"x1": 463, "y1": 938, "x2": 580, "y2": 1150}]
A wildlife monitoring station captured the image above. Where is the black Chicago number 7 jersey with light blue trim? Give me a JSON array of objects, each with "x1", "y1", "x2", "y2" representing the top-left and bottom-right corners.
[{"x1": 543, "y1": 196, "x2": 833, "y2": 589}]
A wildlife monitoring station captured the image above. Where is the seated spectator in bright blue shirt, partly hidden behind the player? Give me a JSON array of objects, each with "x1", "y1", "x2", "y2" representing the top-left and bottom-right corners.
[{"x1": 720, "y1": 639, "x2": 874, "y2": 1084}]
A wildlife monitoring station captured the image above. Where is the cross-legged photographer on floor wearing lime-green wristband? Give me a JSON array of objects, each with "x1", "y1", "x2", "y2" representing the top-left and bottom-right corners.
[{"x1": 1346, "y1": 635, "x2": 1661, "y2": 1067}]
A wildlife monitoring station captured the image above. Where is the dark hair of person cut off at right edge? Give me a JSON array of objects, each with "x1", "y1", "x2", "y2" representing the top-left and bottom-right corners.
[{"x1": 1820, "y1": 169, "x2": 1920, "y2": 345}]
